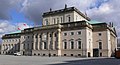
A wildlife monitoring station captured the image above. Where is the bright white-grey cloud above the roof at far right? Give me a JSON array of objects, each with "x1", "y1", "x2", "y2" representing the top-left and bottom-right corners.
[{"x1": 87, "y1": 0, "x2": 120, "y2": 37}]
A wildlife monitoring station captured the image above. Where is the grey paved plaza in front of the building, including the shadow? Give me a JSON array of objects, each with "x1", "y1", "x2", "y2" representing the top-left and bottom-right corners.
[{"x1": 0, "y1": 55, "x2": 120, "y2": 65}]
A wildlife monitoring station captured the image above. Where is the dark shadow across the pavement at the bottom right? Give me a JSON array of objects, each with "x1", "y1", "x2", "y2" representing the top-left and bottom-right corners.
[{"x1": 49, "y1": 58, "x2": 120, "y2": 65}]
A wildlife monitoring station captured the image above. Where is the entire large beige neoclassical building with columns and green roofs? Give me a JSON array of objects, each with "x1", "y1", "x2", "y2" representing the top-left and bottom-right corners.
[{"x1": 1, "y1": 6, "x2": 117, "y2": 57}]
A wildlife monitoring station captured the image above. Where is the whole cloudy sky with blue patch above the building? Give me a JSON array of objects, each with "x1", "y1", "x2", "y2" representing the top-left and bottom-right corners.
[{"x1": 0, "y1": 0, "x2": 120, "y2": 42}]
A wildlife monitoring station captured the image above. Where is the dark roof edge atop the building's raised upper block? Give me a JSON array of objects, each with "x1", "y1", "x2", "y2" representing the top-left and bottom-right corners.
[{"x1": 43, "y1": 7, "x2": 90, "y2": 21}]
